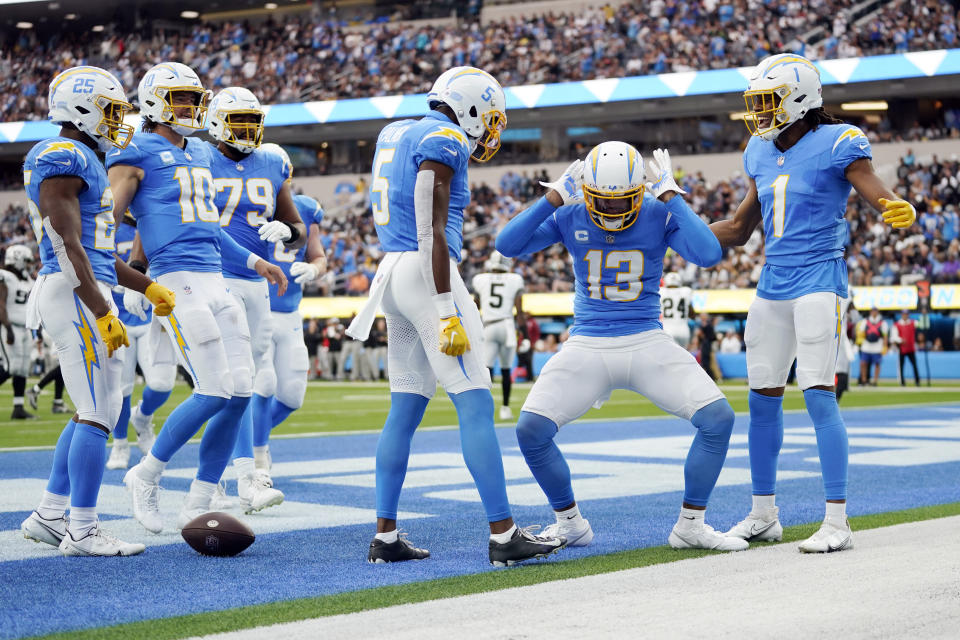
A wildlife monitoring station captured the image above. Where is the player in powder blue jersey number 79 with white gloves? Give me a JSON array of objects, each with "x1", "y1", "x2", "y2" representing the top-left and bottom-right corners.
[{"x1": 208, "y1": 87, "x2": 307, "y2": 513}]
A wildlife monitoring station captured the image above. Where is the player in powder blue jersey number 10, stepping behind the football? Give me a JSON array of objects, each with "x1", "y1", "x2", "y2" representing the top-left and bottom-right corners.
[{"x1": 107, "y1": 62, "x2": 286, "y2": 533}]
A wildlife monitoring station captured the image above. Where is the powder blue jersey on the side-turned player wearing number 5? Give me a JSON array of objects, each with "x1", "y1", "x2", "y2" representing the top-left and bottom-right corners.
[{"x1": 370, "y1": 111, "x2": 470, "y2": 262}]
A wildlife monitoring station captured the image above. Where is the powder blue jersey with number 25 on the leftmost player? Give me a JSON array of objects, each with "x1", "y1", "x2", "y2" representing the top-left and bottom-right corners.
[{"x1": 23, "y1": 136, "x2": 117, "y2": 284}]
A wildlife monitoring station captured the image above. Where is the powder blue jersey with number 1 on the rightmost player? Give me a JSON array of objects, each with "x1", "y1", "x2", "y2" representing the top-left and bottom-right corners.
[{"x1": 743, "y1": 124, "x2": 871, "y2": 300}]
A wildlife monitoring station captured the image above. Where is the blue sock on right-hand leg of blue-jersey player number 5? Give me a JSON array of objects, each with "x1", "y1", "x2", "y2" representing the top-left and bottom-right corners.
[{"x1": 450, "y1": 389, "x2": 510, "y2": 522}]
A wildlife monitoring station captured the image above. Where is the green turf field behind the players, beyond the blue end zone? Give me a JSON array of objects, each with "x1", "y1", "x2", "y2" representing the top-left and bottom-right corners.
[{"x1": 0, "y1": 381, "x2": 960, "y2": 448}]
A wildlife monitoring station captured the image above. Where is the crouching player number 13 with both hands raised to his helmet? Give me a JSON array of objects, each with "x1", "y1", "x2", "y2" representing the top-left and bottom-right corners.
[{"x1": 496, "y1": 141, "x2": 747, "y2": 551}]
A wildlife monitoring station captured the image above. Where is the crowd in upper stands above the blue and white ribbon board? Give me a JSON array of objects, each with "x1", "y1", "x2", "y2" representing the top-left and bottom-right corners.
[{"x1": 0, "y1": 0, "x2": 957, "y2": 121}]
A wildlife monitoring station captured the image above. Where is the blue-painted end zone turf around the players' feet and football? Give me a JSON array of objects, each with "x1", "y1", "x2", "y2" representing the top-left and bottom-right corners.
[{"x1": 0, "y1": 404, "x2": 960, "y2": 639}]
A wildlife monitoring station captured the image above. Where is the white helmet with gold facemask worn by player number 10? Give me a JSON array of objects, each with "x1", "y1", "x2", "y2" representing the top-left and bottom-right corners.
[{"x1": 137, "y1": 62, "x2": 211, "y2": 136}]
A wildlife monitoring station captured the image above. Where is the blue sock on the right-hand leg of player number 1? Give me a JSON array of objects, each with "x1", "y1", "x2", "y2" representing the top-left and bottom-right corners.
[{"x1": 803, "y1": 389, "x2": 849, "y2": 500}]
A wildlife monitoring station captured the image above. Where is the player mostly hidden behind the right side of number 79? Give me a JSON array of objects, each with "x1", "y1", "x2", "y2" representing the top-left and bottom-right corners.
[{"x1": 250, "y1": 195, "x2": 327, "y2": 478}]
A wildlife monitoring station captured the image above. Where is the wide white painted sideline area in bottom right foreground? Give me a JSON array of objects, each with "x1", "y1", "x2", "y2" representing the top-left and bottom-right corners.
[{"x1": 186, "y1": 516, "x2": 960, "y2": 640}]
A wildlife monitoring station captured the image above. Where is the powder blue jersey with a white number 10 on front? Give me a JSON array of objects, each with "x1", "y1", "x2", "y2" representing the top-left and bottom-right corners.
[{"x1": 107, "y1": 133, "x2": 221, "y2": 278}]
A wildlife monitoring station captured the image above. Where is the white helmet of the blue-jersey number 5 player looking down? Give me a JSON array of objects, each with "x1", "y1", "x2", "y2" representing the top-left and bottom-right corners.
[{"x1": 427, "y1": 67, "x2": 507, "y2": 162}]
